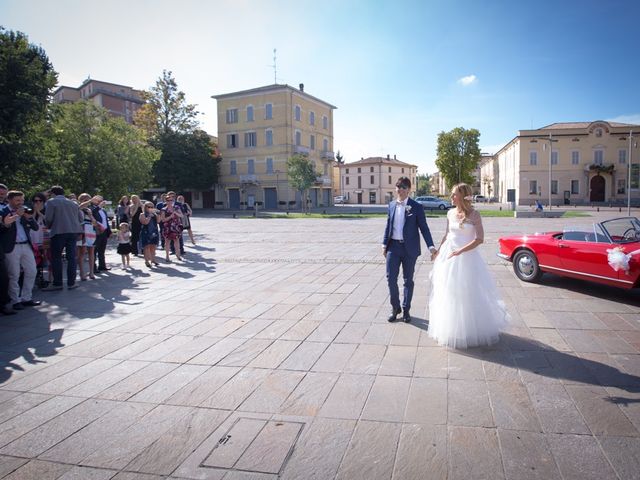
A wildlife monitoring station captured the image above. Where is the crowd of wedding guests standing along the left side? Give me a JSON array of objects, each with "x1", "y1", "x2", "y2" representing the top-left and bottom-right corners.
[{"x1": 0, "y1": 184, "x2": 195, "y2": 315}]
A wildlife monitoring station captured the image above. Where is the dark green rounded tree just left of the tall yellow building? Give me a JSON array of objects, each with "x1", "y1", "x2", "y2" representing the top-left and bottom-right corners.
[{"x1": 153, "y1": 130, "x2": 221, "y2": 191}]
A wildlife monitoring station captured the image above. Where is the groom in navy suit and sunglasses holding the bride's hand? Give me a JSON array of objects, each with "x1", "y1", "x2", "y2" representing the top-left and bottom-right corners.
[{"x1": 382, "y1": 177, "x2": 438, "y2": 323}]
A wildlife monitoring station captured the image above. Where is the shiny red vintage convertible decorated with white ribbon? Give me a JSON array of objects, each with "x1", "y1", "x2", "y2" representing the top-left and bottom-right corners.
[{"x1": 498, "y1": 217, "x2": 640, "y2": 289}]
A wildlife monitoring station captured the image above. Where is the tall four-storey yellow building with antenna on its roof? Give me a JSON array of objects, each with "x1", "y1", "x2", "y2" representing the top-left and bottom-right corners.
[{"x1": 212, "y1": 84, "x2": 336, "y2": 209}]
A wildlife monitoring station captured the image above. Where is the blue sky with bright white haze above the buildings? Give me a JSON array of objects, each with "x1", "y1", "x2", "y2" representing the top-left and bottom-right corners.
[{"x1": 0, "y1": 0, "x2": 640, "y2": 173}]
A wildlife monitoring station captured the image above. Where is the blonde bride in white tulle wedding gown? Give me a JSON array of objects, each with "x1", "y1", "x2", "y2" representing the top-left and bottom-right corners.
[{"x1": 429, "y1": 183, "x2": 508, "y2": 348}]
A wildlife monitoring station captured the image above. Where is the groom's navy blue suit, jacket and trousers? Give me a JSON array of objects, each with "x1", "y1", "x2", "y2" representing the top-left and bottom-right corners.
[{"x1": 382, "y1": 198, "x2": 435, "y2": 315}]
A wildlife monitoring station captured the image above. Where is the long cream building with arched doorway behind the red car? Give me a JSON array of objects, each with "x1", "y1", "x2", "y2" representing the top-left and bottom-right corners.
[{"x1": 492, "y1": 121, "x2": 640, "y2": 205}]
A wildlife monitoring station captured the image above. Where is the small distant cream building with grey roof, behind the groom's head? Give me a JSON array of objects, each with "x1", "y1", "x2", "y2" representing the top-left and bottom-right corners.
[{"x1": 339, "y1": 155, "x2": 417, "y2": 205}]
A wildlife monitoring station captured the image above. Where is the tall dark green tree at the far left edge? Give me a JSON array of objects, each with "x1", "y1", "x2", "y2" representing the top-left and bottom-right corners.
[{"x1": 0, "y1": 27, "x2": 57, "y2": 186}]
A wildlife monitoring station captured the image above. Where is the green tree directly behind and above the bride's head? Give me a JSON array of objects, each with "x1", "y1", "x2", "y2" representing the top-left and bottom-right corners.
[{"x1": 436, "y1": 127, "x2": 480, "y2": 189}]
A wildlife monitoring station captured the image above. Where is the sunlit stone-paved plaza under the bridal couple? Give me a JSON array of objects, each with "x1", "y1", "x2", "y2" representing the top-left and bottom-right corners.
[{"x1": 0, "y1": 209, "x2": 640, "y2": 480}]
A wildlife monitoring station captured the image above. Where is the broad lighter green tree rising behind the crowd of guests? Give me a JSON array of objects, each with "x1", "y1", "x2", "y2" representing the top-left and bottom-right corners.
[{"x1": 53, "y1": 101, "x2": 159, "y2": 200}]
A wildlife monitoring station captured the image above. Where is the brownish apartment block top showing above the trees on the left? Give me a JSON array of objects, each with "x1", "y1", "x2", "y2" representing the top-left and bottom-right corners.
[{"x1": 53, "y1": 78, "x2": 144, "y2": 123}]
